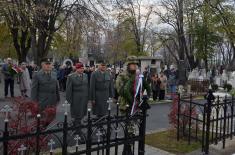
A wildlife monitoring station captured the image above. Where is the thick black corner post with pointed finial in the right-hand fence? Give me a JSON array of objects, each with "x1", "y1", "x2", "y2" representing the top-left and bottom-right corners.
[{"x1": 205, "y1": 90, "x2": 215, "y2": 155}]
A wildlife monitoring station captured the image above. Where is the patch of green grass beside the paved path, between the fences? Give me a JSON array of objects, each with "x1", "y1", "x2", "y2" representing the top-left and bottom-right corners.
[{"x1": 146, "y1": 130, "x2": 201, "y2": 154}]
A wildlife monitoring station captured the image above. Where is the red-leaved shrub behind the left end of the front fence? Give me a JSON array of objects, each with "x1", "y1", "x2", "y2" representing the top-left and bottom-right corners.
[{"x1": 1, "y1": 97, "x2": 56, "y2": 154}]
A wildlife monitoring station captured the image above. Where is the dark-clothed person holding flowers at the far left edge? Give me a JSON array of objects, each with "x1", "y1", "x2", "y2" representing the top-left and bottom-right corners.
[{"x1": 2, "y1": 58, "x2": 15, "y2": 98}]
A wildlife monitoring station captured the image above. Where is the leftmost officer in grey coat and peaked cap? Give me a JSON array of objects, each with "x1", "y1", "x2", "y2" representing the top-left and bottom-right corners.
[{"x1": 31, "y1": 58, "x2": 60, "y2": 112}]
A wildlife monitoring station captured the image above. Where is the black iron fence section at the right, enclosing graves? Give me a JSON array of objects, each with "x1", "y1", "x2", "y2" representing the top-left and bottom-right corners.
[{"x1": 177, "y1": 92, "x2": 235, "y2": 154}]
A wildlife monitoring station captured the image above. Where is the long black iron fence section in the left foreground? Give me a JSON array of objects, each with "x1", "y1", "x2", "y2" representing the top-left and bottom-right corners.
[{"x1": 0, "y1": 99, "x2": 150, "y2": 155}]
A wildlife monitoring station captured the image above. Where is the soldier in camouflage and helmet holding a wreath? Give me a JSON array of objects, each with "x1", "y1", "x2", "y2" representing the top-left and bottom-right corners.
[{"x1": 116, "y1": 56, "x2": 150, "y2": 155}]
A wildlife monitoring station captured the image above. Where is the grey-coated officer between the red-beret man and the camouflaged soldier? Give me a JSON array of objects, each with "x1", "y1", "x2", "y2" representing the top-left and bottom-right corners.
[{"x1": 90, "y1": 61, "x2": 114, "y2": 117}]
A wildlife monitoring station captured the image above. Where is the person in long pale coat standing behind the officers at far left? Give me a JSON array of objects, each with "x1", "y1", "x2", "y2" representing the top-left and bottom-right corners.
[{"x1": 19, "y1": 62, "x2": 31, "y2": 97}]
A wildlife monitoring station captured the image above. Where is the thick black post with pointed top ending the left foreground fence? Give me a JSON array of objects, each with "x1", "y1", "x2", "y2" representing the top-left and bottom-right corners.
[{"x1": 138, "y1": 95, "x2": 150, "y2": 155}]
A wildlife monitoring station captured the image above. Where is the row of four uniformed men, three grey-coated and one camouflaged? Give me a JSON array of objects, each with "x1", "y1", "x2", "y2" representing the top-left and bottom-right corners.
[{"x1": 31, "y1": 56, "x2": 149, "y2": 124}]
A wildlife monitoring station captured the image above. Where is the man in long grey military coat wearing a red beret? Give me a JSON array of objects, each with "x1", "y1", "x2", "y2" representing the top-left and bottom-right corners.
[{"x1": 66, "y1": 63, "x2": 89, "y2": 125}]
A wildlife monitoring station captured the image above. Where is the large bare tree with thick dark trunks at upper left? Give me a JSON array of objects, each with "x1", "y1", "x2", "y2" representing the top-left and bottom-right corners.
[{"x1": 0, "y1": 0, "x2": 104, "y2": 64}]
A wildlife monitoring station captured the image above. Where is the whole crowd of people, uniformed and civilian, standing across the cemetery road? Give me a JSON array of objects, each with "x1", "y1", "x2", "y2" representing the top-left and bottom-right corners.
[{"x1": 2, "y1": 57, "x2": 177, "y2": 124}]
